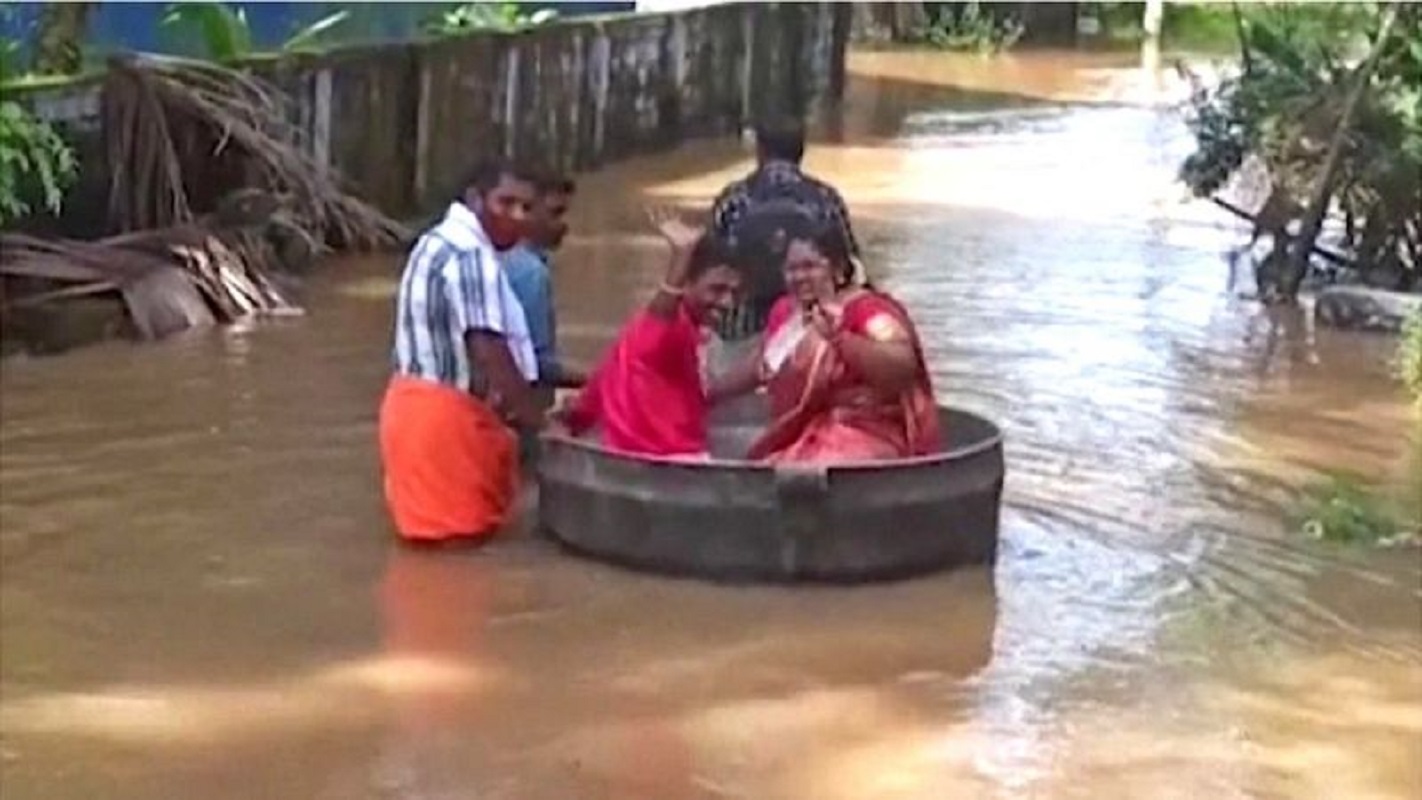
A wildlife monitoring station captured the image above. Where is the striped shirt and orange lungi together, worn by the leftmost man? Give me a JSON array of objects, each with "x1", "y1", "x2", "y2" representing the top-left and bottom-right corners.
[{"x1": 380, "y1": 203, "x2": 538, "y2": 541}]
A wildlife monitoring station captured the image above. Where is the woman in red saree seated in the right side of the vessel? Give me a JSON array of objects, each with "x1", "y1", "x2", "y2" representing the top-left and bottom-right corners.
[{"x1": 718, "y1": 223, "x2": 941, "y2": 462}]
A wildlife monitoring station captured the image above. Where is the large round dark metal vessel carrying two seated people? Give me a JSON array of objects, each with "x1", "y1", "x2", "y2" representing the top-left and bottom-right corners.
[{"x1": 538, "y1": 398, "x2": 1005, "y2": 584}]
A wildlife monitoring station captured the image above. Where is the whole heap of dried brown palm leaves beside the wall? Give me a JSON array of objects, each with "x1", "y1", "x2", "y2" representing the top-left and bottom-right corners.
[{"x1": 0, "y1": 55, "x2": 407, "y2": 348}]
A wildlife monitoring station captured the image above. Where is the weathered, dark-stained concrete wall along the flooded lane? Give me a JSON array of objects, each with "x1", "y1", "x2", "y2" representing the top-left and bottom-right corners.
[{"x1": 19, "y1": 3, "x2": 849, "y2": 221}]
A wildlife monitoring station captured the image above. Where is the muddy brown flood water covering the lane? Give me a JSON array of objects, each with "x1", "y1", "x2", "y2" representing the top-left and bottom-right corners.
[{"x1": 0, "y1": 54, "x2": 1422, "y2": 800}]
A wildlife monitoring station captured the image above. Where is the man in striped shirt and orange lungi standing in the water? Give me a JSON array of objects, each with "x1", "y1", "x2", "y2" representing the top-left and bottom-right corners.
[{"x1": 380, "y1": 162, "x2": 543, "y2": 543}]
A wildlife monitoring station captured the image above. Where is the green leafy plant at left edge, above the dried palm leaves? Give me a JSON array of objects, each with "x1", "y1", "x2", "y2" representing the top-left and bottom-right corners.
[{"x1": 0, "y1": 101, "x2": 78, "y2": 225}]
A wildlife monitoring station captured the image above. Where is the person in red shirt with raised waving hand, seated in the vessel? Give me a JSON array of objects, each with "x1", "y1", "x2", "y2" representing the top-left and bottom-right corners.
[{"x1": 565, "y1": 220, "x2": 739, "y2": 458}]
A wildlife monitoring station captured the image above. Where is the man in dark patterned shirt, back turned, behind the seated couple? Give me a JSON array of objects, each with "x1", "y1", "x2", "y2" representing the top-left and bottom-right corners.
[{"x1": 711, "y1": 117, "x2": 859, "y2": 341}]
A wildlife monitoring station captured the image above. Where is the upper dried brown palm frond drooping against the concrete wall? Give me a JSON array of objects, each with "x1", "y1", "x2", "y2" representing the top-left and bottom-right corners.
[{"x1": 102, "y1": 55, "x2": 408, "y2": 249}]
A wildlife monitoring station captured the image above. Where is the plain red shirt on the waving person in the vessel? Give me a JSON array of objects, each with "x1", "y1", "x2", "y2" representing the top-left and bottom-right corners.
[{"x1": 567, "y1": 307, "x2": 707, "y2": 456}]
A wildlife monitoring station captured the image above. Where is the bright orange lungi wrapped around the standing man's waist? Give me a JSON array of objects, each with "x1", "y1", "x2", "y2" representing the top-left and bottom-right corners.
[{"x1": 380, "y1": 375, "x2": 519, "y2": 541}]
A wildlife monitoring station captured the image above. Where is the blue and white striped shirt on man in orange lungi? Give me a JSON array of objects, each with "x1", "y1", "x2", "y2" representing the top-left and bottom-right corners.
[{"x1": 394, "y1": 203, "x2": 538, "y2": 391}]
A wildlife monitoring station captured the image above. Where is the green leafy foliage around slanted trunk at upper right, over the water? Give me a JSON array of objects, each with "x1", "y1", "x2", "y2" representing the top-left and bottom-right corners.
[{"x1": 1180, "y1": 3, "x2": 1422, "y2": 288}]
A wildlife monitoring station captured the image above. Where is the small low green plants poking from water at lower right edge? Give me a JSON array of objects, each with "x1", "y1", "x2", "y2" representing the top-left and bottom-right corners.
[{"x1": 1295, "y1": 473, "x2": 1419, "y2": 547}]
